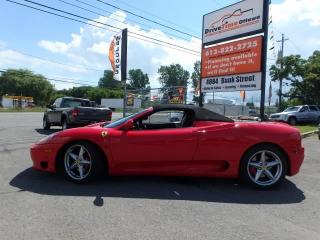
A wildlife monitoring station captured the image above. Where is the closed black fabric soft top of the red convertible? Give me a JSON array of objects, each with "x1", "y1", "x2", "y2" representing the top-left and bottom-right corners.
[{"x1": 153, "y1": 104, "x2": 234, "y2": 122}]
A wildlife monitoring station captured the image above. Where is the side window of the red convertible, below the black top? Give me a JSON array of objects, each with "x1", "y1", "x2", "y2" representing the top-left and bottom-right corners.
[{"x1": 143, "y1": 110, "x2": 184, "y2": 124}]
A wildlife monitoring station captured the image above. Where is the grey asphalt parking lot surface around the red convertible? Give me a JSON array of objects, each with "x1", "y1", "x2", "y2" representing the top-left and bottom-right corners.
[{"x1": 0, "y1": 113, "x2": 320, "y2": 240}]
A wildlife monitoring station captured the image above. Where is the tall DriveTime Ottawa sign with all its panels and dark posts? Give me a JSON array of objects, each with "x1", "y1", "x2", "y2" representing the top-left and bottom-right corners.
[{"x1": 199, "y1": 0, "x2": 269, "y2": 120}]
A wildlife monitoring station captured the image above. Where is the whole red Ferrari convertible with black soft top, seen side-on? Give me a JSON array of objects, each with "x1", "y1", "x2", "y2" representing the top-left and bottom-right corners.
[{"x1": 31, "y1": 105, "x2": 304, "y2": 188}]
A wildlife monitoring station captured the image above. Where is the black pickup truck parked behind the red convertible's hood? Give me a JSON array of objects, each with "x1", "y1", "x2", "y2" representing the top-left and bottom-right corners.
[{"x1": 43, "y1": 97, "x2": 112, "y2": 130}]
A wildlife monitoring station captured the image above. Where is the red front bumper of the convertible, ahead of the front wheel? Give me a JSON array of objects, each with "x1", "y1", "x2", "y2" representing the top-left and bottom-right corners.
[{"x1": 30, "y1": 144, "x2": 60, "y2": 172}]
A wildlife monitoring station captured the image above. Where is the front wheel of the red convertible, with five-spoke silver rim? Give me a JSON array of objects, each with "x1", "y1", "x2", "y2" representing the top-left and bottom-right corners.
[{"x1": 59, "y1": 142, "x2": 106, "y2": 183}]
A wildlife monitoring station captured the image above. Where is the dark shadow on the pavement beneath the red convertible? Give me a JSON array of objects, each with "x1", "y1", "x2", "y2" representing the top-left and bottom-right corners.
[{"x1": 10, "y1": 168, "x2": 305, "y2": 206}]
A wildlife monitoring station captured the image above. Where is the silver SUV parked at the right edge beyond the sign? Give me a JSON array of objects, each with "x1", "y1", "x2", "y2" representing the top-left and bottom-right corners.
[{"x1": 270, "y1": 105, "x2": 320, "y2": 125}]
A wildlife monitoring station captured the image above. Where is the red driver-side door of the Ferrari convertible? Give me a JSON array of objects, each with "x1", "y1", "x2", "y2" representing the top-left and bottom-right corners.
[{"x1": 111, "y1": 110, "x2": 198, "y2": 175}]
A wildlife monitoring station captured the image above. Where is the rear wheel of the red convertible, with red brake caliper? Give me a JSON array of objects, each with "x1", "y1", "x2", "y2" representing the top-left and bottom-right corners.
[{"x1": 240, "y1": 145, "x2": 287, "y2": 189}]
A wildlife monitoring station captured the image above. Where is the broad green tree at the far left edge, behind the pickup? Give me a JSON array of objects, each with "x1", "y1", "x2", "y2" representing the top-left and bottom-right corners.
[{"x1": 0, "y1": 69, "x2": 55, "y2": 106}]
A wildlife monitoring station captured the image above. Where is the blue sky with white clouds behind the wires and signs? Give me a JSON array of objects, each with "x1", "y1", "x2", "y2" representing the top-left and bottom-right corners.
[{"x1": 0, "y1": 0, "x2": 320, "y2": 102}]
